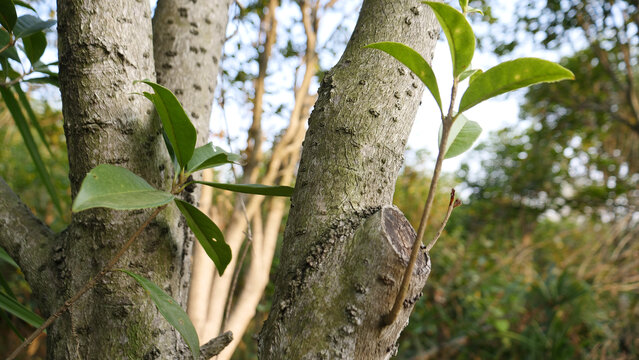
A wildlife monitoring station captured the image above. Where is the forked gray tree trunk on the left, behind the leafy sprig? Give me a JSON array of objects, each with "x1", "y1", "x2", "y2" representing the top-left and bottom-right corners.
[{"x1": 0, "y1": 0, "x2": 229, "y2": 359}]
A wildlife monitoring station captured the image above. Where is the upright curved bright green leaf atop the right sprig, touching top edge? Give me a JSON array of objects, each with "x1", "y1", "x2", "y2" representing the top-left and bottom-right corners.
[{"x1": 424, "y1": 1, "x2": 475, "y2": 78}]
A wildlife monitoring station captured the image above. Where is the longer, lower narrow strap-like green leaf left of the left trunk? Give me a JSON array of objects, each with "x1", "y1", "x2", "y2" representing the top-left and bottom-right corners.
[{"x1": 0, "y1": 87, "x2": 62, "y2": 215}]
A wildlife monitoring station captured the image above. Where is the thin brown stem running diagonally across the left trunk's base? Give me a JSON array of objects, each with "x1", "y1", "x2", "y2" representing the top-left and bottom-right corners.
[{"x1": 6, "y1": 205, "x2": 167, "y2": 360}]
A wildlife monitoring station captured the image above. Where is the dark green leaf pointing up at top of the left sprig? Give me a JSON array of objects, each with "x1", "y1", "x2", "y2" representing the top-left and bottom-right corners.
[{"x1": 140, "y1": 80, "x2": 197, "y2": 168}]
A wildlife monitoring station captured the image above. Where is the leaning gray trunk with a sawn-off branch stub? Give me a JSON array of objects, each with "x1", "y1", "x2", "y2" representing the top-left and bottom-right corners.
[{"x1": 260, "y1": 0, "x2": 439, "y2": 360}]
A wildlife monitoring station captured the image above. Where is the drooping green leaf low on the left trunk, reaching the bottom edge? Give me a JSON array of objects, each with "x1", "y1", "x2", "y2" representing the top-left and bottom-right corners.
[{"x1": 120, "y1": 269, "x2": 200, "y2": 360}]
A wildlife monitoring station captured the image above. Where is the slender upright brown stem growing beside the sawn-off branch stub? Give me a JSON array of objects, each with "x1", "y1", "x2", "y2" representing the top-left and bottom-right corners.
[{"x1": 382, "y1": 77, "x2": 459, "y2": 326}]
